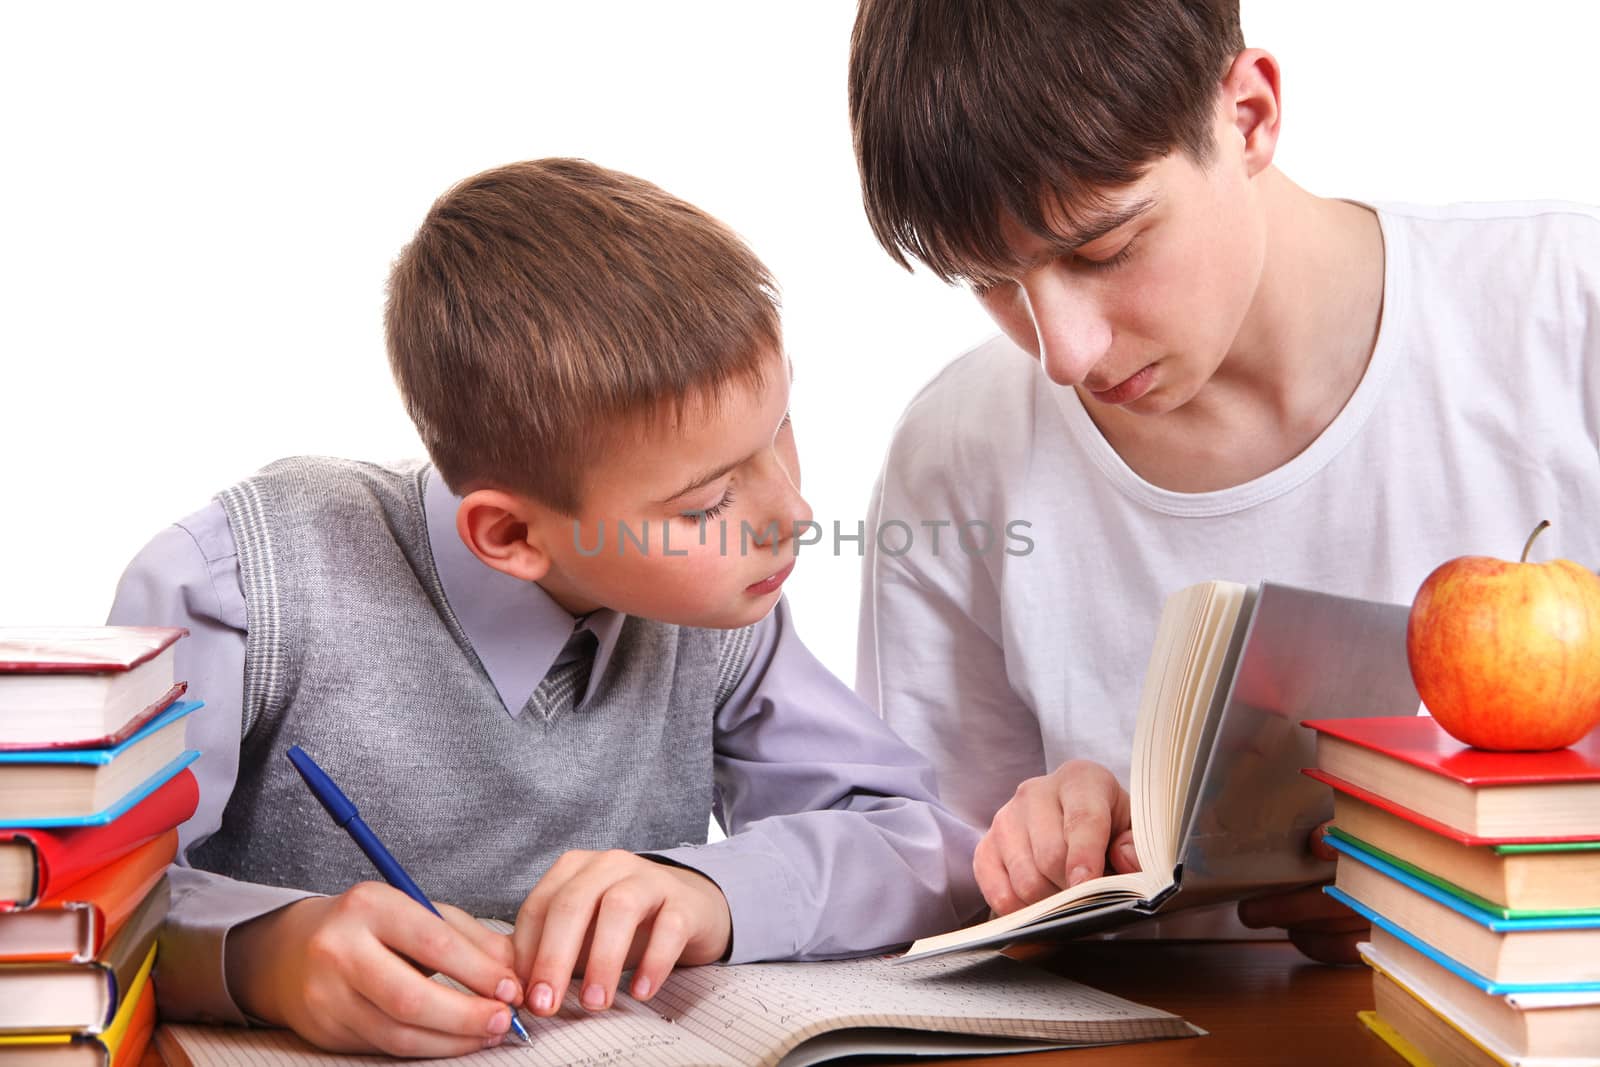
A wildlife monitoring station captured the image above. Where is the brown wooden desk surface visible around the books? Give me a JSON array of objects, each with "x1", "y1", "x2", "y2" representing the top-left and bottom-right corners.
[{"x1": 139, "y1": 941, "x2": 1403, "y2": 1067}]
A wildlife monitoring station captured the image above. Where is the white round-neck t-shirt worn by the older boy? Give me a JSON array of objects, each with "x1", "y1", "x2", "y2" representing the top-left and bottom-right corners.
[{"x1": 858, "y1": 203, "x2": 1600, "y2": 827}]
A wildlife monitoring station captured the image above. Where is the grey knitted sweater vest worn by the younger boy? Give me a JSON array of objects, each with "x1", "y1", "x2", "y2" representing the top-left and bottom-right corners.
[{"x1": 190, "y1": 459, "x2": 750, "y2": 920}]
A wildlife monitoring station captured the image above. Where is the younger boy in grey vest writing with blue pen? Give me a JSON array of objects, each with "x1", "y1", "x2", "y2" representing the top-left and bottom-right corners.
[{"x1": 112, "y1": 160, "x2": 981, "y2": 1056}]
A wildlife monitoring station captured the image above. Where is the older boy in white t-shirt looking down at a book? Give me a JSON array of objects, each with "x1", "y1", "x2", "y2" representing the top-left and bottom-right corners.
[{"x1": 850, "y1": 0, "x2": 1600, "y2": 958}]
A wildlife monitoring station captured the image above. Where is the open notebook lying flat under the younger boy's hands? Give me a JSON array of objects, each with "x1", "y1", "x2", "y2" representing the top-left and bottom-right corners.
[{"x1": 157, "y1": 923, "x2": 1203, "y2": 1067}]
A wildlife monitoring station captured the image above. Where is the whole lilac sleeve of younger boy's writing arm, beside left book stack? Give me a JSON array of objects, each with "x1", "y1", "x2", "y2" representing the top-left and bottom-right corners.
[{"x1": 107, "y1": 502, "x2": 310, "y2": 1024}]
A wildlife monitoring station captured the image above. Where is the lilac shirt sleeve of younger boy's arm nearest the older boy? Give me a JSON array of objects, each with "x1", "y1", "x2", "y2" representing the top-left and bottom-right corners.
[{"x1": 643, "y1": 601, "x2": 982, "y2": 963}]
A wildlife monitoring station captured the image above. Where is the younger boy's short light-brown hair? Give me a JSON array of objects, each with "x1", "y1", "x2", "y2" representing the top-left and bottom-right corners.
[{"x1": 384, "y1": 160, "x2": 781, "y2": 515}]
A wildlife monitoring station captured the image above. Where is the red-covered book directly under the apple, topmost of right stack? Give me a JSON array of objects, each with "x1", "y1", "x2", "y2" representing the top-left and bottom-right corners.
[{"x1": 1306, "y1": 715, "x2": 1600, "y2": 845}]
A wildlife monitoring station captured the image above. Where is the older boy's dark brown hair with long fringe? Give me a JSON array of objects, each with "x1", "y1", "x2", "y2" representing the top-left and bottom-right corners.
[{"x1": 850, "y1": 0, "x2": 1245, "y2": 282}]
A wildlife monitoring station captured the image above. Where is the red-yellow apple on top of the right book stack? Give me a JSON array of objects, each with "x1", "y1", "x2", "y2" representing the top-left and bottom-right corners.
[{"x1": 1405, "y1": 522, "x2": 1600, "y2": 752}]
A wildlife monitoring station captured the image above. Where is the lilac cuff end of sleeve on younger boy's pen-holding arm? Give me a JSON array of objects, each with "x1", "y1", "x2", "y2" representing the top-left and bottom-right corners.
[{"x1": 155, "y1": 867, "x2": 317, "y2": 1025}]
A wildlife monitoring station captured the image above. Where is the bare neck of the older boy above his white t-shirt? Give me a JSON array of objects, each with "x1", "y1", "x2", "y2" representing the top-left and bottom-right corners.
[{"x1": 1094, "y1": 168, "x2": 1384, "y2": 493}]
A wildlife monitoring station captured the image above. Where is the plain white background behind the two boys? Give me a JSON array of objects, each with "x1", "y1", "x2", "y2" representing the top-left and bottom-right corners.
[{"x1": 0, "y1": 0, "x2": 1600, "y2": 678}]
